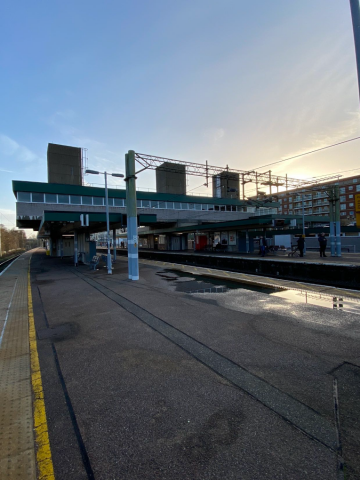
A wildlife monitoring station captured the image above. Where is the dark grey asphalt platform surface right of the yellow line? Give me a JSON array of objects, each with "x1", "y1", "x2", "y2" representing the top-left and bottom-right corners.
[{"x1": 26, "y1": 250, "x2": 360, "y2": 480}]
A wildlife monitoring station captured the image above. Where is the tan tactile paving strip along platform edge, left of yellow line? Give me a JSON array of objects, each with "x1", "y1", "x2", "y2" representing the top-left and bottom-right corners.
[{"x1": 0, "y1": 255, "x2": 36, "y2": 480}]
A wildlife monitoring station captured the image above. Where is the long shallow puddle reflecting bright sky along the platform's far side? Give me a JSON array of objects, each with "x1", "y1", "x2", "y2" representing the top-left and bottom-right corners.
[{"x1": 157, "y1": 270, "x2": 360, "y2": 315}]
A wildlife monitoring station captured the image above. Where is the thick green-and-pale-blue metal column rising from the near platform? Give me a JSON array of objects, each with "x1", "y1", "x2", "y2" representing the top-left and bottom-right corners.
[{"x1": 125, "y1": 150, "x2": 139, "y2": 280}]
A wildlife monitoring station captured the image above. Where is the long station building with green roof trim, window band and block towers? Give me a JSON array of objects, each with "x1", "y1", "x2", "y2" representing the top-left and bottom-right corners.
[{"x1": 13, "y1": 144, "x2": 340, "y2": 263}]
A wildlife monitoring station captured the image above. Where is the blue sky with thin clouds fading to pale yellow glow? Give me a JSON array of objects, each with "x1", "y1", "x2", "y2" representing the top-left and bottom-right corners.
[{"x1": 0, "y1": 0, "x2": 360, "y2": 232}]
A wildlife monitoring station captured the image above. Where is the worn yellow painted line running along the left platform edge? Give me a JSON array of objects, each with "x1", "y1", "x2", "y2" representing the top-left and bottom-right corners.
[{"x1": 28, "y1": 257, "x2": 55, "y2": 480}]
